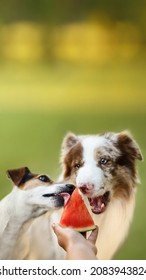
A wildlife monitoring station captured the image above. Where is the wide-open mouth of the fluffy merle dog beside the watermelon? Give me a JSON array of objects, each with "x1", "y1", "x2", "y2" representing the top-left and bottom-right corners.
[{"x1": 88, "y1": 191, "x2": 110, "y2": 214}]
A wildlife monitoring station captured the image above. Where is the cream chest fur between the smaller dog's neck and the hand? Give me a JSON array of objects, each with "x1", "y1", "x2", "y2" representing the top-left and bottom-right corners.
[{"x1": 14, "y1": 209, "x2": 65, "y2": 260}]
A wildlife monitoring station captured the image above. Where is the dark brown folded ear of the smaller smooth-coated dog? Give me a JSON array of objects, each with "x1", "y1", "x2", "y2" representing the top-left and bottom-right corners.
[{"x1": 7, "y1": 167, "x2": 34, "y2": 187}]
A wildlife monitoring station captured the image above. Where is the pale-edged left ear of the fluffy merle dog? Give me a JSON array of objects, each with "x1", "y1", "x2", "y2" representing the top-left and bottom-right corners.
[{"x1": 62, "y1": 132, "x2": 79, "y2": 152}]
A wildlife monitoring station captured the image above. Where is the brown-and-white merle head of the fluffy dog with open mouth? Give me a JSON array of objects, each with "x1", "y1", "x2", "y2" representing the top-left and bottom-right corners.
[{"x1": 61, "y1": 131, "x2": 142, "y2": 214}]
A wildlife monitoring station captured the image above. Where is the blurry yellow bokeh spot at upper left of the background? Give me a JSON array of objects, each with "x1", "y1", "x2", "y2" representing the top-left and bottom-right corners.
[{"x1": 2, "y1": 22, "x2": 43, "y2": 61}]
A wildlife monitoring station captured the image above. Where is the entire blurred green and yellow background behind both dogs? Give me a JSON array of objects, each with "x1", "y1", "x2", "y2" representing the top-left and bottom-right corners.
[{"x1": 0, "y1": 0, "x2": 146, "y2": 259}]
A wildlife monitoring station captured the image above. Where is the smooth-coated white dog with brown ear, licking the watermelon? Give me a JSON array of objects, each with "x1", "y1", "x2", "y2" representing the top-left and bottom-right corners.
[{"x1": 0, "y1": 167, "x2": 75, "y2": 259}]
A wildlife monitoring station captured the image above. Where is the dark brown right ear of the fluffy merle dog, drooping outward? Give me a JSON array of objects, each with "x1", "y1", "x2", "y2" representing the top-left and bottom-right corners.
[{"x1": 117, "y1": 130, "x2": 143, "y2": 160}]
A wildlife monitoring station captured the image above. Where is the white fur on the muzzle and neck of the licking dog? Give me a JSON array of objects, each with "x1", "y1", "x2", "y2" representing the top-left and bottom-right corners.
[{"x1": 0, "y1": 184, "x2": 64, "y2": 259}]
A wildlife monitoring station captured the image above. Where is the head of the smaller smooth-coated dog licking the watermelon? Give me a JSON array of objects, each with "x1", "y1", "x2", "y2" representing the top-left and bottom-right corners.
[{"x1": 7, "y1": 167, "x2": 75, "y2": 216}]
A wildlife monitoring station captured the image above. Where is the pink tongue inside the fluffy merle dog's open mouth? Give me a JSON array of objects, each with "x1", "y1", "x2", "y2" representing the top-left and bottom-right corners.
[{"x1": 90, "y1": 196, "x2": 105, "y2": 214}]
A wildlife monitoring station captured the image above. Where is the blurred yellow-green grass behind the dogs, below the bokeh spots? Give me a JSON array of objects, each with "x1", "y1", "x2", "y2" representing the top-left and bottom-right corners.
[{"x1": 0, "y1": 62, "x2": 146, "y2": 259}]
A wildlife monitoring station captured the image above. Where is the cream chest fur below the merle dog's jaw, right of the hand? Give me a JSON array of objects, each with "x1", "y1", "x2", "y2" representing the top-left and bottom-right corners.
[{"x1": 93, "y1": 191, "x2": 135, "y2": 260}]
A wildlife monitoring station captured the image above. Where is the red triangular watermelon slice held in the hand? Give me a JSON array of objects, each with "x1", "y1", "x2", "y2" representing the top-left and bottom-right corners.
[{"x1": 60, "y1": 188, "x2": 96, "y2": 232}]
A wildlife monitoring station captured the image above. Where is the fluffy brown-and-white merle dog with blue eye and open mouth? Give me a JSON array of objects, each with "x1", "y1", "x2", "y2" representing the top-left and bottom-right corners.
[{"x1": 61, "y1": 131, "x2": 142, "y2": 259}]
